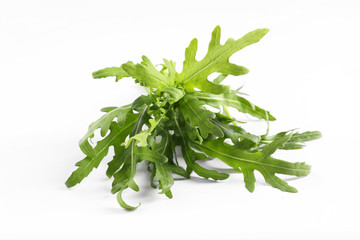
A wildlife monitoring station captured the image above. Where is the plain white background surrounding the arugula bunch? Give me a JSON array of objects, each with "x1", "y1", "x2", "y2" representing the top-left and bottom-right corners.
[{"x1": 0, "y1": 0, "x2": 360, "y2": 240}]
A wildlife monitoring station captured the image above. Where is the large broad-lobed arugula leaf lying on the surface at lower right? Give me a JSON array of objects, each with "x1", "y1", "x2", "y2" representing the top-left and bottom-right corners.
[{"x1": 194, "y1": 135, "x2": 310, "y2": 192}]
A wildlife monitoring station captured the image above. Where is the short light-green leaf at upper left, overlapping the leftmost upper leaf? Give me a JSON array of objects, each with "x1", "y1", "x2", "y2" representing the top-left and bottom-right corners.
[{"x1": 121, "y1": 56, "x2": 174, "y2": 90}]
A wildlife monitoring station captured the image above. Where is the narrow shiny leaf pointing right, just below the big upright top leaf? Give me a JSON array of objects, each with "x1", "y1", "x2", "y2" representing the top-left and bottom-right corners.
[{"x1": 194, "y1": 92, "x2": 276, "y2": 121}]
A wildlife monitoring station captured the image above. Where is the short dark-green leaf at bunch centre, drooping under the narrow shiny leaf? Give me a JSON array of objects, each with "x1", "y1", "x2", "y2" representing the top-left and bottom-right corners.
[{"x1": 180, "y1": 94, "x2": 224, "y2": 138}]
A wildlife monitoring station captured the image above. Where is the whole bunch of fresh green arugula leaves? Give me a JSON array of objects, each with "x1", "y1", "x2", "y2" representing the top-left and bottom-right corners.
[{"x1": 66, "y1": 26, "x2": 320, "y2": 210}]
